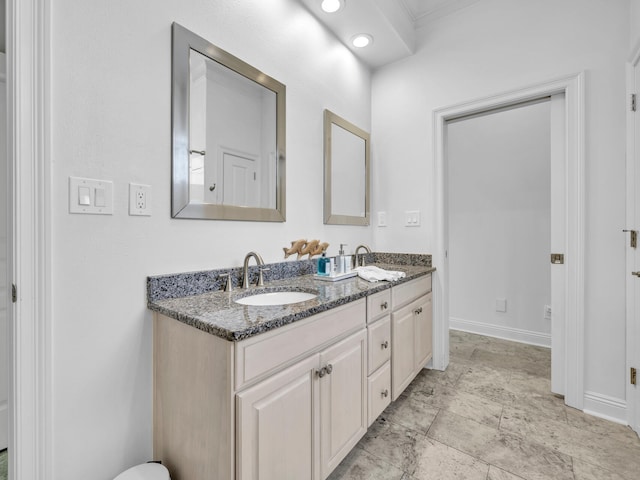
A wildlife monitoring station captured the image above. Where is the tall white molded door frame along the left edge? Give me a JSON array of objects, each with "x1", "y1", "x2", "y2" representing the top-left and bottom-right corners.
[{"x1": 6, "y1": 0, "x2": 53, "y2": 480}]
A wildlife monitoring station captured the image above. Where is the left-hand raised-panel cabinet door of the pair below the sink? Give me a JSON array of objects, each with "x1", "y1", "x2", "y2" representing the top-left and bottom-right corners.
[{"x1": 236, "y1": 354, "x2": 319, "y2": 480}]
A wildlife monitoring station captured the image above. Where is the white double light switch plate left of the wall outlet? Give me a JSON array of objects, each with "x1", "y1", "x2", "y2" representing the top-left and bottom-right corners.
[{"x1": 69, "y1": 177, "x2": 113, "y2": 215}]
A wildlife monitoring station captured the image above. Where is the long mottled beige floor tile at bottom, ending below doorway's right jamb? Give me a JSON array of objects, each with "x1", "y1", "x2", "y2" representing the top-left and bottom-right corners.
[{"x1": 428, "y1": 411, "x2": 574, "y2": 480}]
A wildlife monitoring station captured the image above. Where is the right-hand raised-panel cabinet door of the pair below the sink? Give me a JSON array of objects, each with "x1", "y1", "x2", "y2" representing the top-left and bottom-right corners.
[{"x1": 318, "y1": 330, "x2": 368, "y2": 480}]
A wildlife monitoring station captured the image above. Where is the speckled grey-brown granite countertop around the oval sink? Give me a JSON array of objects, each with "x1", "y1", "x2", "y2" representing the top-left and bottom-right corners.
[{"x1": 148, "y1": 262, "x2": 435, "y2": 341}]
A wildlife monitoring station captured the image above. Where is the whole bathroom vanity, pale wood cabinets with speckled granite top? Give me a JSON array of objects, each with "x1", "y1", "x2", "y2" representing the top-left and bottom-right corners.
[{"x1": 149, "y1": 256, "x2": 433, "y2": 480}]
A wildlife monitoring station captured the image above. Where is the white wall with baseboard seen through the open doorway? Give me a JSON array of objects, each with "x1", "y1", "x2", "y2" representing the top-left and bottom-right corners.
[{"x1": 447, "y1": 102, "x2": 551, "y2": 346}]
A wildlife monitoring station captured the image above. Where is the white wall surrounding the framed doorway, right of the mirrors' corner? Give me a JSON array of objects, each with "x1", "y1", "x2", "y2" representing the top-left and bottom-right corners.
[{"x1": 372, "y1": 0, "x2": 629, "y2": 403}]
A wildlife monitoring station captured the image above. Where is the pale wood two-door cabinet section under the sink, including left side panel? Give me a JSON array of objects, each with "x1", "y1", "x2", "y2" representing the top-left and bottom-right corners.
[{"x1": 154, "y1": 299, "x2": 368, "y2": 480}]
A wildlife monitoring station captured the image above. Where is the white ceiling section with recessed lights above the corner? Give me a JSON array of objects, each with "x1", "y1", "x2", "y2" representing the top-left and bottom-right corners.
[{"x1": 300, "y1": 0, "x2": 480, "y2": 69}]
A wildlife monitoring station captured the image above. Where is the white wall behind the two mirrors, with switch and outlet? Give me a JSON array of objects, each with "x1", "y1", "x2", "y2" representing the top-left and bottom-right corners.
[{"x1": 50, "y1": 0, "x2": 372, "y2": 480}]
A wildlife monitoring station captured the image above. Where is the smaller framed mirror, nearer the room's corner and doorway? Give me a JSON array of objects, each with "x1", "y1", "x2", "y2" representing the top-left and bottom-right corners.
[{"x1": 324, "y1": 110, "x2": 370, "y2": 225}]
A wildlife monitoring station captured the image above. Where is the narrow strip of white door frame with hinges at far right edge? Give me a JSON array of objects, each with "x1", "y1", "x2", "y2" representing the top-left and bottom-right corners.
[{"x1": 625, "y1": 45, "x2": 640, "y2": 433}]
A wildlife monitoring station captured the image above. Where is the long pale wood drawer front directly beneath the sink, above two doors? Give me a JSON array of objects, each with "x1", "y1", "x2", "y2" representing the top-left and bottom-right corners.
[{"x1": 235, "y1": 299, "x2": 366, "y2": 391}]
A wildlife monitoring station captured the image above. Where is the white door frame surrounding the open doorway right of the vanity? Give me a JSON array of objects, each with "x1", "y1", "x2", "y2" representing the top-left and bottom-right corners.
[{"x1": 433, "y1": 72, "x2": 585, "y2": 410}]
